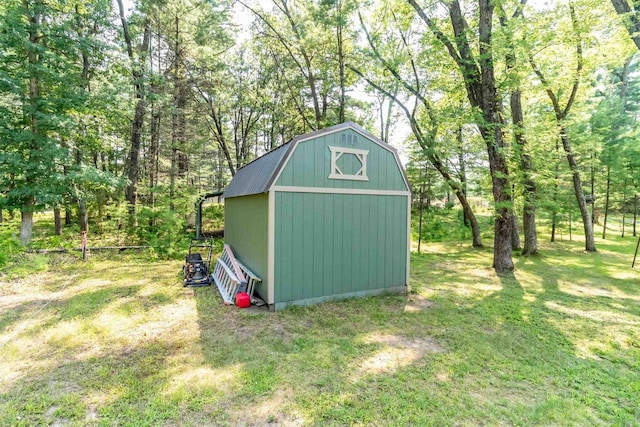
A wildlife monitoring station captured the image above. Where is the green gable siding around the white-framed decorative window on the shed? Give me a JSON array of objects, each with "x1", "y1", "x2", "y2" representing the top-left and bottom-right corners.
[{"x1": 276, "y1": 129, "x2": 408, "y2": 191}]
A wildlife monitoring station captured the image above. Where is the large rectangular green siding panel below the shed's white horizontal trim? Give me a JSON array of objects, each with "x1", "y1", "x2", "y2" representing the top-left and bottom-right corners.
[{"x1": 274, "y1": 192, "x2": 407, "y2": 304}]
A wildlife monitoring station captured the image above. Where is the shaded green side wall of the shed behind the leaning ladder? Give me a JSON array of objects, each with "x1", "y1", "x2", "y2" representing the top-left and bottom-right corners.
[{"x1": 224, "y1": 194, "x2": 269, "y2": 301}]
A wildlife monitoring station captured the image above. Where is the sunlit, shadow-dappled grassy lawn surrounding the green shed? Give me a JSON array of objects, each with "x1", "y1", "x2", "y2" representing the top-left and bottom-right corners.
[{"x1": 0, "y1": 234, "x2": 640, "y2": 426}]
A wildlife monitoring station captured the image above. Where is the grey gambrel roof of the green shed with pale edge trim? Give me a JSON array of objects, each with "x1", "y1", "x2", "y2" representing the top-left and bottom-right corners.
[{"x1": 223, "y1": 122, "x2": 410, "y2": 198}]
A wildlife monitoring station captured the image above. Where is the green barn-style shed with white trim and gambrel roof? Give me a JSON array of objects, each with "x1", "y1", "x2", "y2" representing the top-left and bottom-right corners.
[{"x1": 223, "y1": 122, "x2": 411, "y2": 310}]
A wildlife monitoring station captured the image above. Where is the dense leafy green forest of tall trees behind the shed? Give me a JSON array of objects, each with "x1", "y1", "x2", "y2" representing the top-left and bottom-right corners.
[{"x1": 0, "y1": 0, "x2": 640, "y2": 271}]
